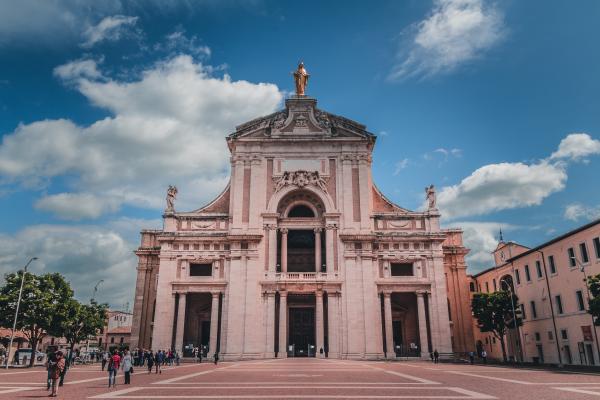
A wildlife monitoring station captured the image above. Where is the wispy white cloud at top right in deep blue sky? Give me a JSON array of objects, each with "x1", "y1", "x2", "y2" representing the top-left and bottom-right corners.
[{"x1": 389, "y1": 0, "x2": 506, "y2": 80}]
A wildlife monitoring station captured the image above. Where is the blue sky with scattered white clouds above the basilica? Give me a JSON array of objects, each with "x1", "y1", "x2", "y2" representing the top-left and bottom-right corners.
[{"x1": 0, "y1": 0, "x2": 600, "y2": 307}]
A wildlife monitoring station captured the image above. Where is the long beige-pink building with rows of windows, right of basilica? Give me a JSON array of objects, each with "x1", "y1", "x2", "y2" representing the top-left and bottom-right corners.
[{"x1": 471, "y1": 220, "x2": 600, "y2": 365}]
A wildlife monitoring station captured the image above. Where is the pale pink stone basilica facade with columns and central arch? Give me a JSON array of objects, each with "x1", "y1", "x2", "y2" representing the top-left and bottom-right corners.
[{"x1": 131, "y1": 95, "x2": 473, "y2": 360}]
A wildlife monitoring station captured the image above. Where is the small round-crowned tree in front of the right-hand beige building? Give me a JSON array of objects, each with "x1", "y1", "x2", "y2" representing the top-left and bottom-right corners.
[{"x1": 471, "y1": 291, "x2": 523, "y2": 362}]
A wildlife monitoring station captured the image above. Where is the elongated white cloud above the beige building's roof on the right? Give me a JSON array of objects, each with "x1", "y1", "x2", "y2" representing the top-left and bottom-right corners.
[{"x1": 438, "y1": 161, "x2": 567, "y2": 218}]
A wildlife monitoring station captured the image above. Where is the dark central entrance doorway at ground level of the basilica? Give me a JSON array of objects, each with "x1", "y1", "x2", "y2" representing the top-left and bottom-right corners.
[{"x1": 288, "y1": 307, "x2": 316, "y2": 357}]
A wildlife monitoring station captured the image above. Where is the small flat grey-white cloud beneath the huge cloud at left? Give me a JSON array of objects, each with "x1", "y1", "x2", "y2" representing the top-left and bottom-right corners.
[{"x1": 34, "y1": 193, "x2": 121, "y2": 220}]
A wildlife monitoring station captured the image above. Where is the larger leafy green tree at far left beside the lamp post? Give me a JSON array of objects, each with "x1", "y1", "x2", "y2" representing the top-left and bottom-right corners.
[{"x1": 0, "y1": 271, "x2": 73, "y2": 367}]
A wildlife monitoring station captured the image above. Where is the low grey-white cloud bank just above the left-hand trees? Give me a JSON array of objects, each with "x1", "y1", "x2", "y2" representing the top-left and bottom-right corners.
[{"x1": 0, "y1": 225, "x2": 136, "y2": 307}]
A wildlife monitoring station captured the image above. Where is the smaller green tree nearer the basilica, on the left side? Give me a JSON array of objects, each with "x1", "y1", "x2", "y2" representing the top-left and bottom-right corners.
[{"x1": 49, "y1": 299, "x2": 108, "y2": 353}]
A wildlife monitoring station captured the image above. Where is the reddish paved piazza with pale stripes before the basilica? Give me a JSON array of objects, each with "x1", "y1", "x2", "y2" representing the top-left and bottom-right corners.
[{"x1": 0, "y1": 359, "x2": 600, "y2": 400}]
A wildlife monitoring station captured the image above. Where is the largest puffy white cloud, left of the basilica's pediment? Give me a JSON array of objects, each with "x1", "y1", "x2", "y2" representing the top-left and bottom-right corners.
[{"x1": 0, "y1": 55, "x2": 282, "y2": 219}]
